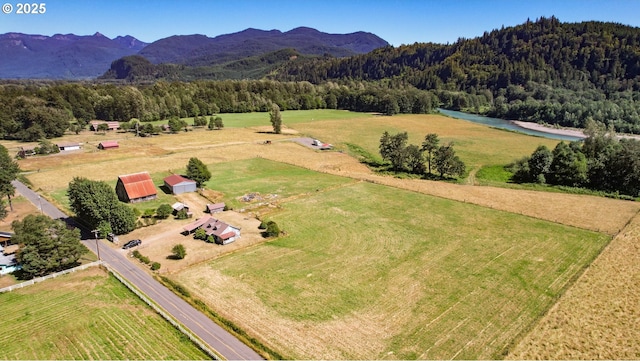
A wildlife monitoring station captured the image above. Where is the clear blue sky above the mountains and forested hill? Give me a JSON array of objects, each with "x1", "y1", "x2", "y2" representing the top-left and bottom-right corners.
[{"x1": 0, "y1": 0, "x2": 640, "y2": 46}]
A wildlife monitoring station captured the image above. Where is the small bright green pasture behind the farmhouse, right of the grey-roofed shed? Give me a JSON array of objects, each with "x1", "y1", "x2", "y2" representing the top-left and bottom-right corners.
[{"x1": 207, "y1": 158, "x2": 356, "y2": 208}]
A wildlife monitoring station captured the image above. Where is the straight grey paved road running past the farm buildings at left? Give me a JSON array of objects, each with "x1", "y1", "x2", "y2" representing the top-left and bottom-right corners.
[{"x1": 12, "y1": 181, "x2": 263, "y2": 360}]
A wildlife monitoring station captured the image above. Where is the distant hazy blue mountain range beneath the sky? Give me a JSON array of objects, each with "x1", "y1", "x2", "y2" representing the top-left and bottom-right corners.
[{"x1": 0, "y1": 27, "x2": 388, "y2": 79}]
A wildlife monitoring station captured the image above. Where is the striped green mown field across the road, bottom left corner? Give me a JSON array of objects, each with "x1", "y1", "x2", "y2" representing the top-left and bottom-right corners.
[{"x1": 0, "y1": 269, "x2": 208, "y2": 360}]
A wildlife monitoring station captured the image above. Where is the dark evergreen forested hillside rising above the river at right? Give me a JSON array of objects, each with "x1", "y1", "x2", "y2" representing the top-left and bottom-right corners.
[{"x1": 276, "y1": 17, "x2": 640, "y2": 133}]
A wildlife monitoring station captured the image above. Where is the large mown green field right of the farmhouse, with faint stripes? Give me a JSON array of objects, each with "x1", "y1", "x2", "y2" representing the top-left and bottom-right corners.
[{"x1": 198, "y1": 181, "x2": 609, "y2": 359}]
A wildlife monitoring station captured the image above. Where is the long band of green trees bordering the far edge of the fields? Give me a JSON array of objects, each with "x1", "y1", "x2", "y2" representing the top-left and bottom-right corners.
[{"x1": 0, "y1": 80, "x2": 438, "y2": 141}]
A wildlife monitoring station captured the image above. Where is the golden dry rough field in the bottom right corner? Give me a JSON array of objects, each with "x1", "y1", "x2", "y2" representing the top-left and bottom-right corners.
[{"x1": 507, "y1": 208, "x2": 640, "y2": 360}]
